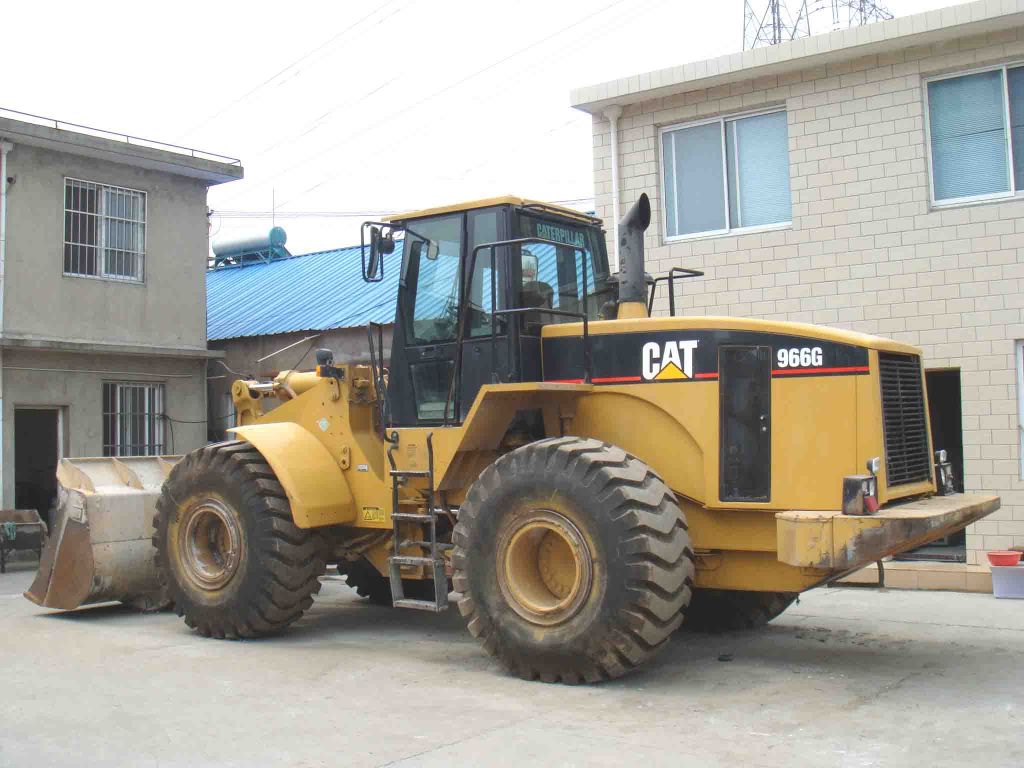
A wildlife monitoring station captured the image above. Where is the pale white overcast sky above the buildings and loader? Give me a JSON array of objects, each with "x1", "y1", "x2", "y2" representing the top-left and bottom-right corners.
[{"x1": 0, "y1": 0, "x2": 951, "y2": 253}]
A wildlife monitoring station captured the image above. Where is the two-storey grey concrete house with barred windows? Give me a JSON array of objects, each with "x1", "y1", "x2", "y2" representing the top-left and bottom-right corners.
[{"x1": 0, "y1": 113, "x2": 243, "y2": 516}]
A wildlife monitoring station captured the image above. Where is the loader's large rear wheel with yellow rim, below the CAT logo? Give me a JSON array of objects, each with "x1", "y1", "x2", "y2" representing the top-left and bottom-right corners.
[{"x1": 452, "y1": 437, "x2": 693, "y2": 683}]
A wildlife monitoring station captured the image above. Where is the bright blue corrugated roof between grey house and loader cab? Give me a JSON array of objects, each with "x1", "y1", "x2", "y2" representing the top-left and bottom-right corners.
[{"x1": 206, "y1": 241, "x2": 402, "y2": 341}]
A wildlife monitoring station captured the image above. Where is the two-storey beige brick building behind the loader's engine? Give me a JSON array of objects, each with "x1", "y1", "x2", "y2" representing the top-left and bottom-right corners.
[{"x1": 571, "y1": 0, "x2": 1024, "y2": 590}]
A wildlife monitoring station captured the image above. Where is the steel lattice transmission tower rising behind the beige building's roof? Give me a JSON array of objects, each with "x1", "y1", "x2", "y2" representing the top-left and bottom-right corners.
[{"x1": 743, "y1": 0, "x2": 893, "y2": 50}]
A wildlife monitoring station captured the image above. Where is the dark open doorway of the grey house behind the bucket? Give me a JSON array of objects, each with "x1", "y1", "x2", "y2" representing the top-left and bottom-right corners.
[{"x1": 14, "y1": 408, "x2": 60, "y2": 528}]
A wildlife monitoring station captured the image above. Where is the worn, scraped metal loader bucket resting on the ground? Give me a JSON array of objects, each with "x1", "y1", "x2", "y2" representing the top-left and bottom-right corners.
[{"x1": 25, "y1": 456, "x2": 180, "y2": 610}]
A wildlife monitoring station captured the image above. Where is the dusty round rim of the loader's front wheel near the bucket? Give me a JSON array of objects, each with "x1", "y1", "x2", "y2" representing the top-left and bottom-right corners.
[{"x1": 178, "y1": 499, "x2": 242, "y2": 590}]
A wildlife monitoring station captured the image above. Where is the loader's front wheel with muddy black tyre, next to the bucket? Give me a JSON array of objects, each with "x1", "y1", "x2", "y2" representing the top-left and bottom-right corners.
[{"x1": 153, "y1": 440, "x2": 327, "y2": 640}]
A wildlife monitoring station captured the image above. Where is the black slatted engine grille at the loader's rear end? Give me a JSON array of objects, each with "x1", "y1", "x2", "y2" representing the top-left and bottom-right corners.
[{"x1": 879, "y1": 352, "x2": 932, "y2": 486}]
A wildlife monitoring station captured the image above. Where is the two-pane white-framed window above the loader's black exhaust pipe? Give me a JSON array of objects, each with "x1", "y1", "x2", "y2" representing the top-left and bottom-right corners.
[{"x1": 662, "y1": 112, "x2": 793, "y2": 239}]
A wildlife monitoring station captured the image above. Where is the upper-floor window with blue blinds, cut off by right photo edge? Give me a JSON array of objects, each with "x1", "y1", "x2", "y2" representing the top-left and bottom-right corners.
[{"x1": 928, "y1": 67, "x2": 1024, "y2": 204}]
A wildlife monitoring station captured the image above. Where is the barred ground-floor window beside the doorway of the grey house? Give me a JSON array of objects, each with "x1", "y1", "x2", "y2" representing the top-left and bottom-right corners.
[{"x1": 103, "y1": 382, "x2": 166, "y2": 456}]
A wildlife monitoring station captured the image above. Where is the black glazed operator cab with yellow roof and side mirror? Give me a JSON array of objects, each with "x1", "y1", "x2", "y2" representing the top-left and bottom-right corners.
[{"x1": 364, "y1": 198, "x2": 614, "y2": 427}]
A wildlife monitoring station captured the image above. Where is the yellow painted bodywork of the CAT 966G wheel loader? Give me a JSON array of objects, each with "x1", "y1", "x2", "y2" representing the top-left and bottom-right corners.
[{"x1": 236, "y1": 317, "x2": 998, "y2": 592}]
